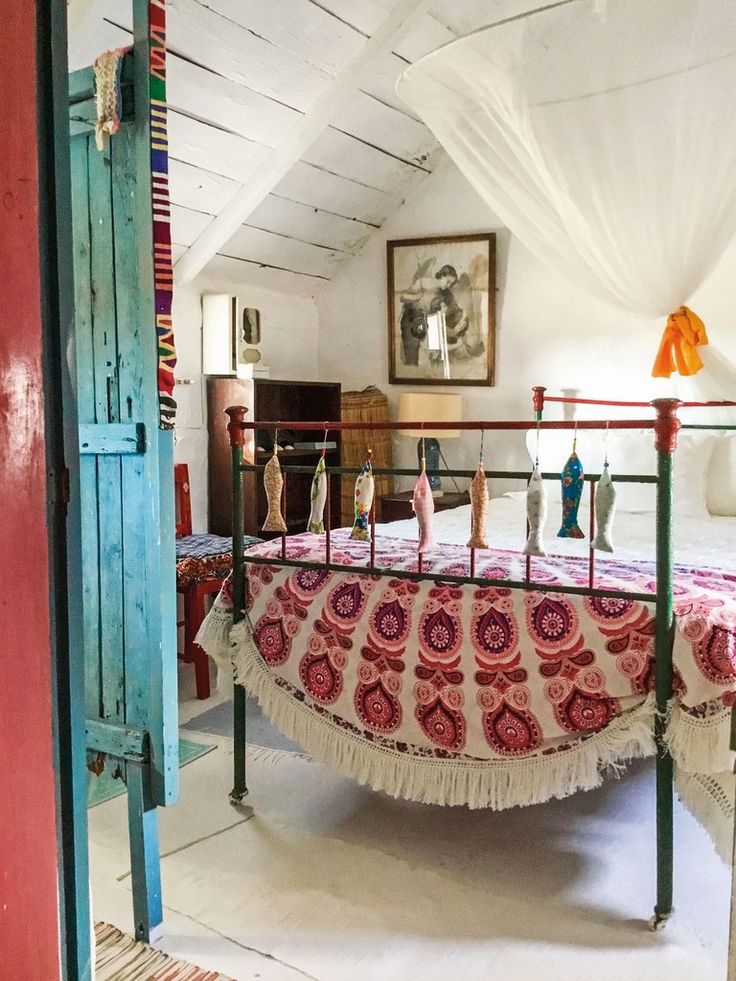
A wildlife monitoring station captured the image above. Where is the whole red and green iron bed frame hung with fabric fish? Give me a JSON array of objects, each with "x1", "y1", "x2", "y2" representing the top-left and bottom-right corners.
[{"x1": 225, "y1": 386, "x2": 736, "y2": 929}]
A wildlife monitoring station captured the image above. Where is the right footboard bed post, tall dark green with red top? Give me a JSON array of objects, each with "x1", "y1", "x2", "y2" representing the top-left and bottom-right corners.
[{"x1": 651, "y1": 399, "x2": 681, "y2": 930}]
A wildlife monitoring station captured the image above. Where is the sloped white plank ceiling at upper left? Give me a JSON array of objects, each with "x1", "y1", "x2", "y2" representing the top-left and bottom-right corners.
[{"x1": 69, "y1": 0, "x2": 508, "y2": 296}]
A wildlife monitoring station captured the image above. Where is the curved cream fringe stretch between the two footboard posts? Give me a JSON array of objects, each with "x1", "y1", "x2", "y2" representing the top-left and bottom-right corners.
[{"x1": 226, "y1": 621, "x2": 654, "y2": 810}]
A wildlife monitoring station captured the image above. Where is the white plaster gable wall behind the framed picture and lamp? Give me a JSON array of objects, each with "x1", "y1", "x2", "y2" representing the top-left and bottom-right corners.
[{"x1": 317, "y1": 158, "x2": 736, "y2": 493}]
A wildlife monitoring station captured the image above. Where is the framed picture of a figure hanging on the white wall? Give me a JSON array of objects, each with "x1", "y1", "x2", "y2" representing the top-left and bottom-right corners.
[{"x1": 386, "y1": 232, "x2": 496, "y2": 385}]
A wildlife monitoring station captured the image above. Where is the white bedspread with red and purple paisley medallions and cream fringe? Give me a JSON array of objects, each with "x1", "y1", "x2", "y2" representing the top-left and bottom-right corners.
[{"x1": 201, "y1": 531, "x2": 736, "y2": 820}]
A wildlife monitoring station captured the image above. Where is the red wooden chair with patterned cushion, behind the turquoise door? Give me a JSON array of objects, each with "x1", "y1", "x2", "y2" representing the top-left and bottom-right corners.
[{"x1": 174, "y1": 463, "x2": 232, "y2": 698}]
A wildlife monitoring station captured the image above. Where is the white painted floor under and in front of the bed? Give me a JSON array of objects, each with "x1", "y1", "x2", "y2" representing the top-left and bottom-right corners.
[{"x1": 90, "y1": 668, "x2": 730, "y2": 981}]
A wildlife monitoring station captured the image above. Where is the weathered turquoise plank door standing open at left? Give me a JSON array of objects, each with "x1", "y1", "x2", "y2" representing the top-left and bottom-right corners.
[{"x1": 69, "y1": 0, "x2": 179, "y2": 940}]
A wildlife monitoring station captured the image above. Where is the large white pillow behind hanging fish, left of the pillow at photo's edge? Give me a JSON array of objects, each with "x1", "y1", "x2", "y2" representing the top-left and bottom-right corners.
[{"x1": 526, "y1": 429, "x2": 716, "y2": 518}]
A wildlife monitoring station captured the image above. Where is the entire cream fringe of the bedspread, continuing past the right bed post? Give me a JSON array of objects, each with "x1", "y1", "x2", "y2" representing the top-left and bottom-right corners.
[{"x1": 197, "y1": 606, "x2": 736, "y2": 816}]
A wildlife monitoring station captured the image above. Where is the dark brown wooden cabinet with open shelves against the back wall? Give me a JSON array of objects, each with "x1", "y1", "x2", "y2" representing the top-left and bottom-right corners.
[{"x1": 207, "y1": 375, "x2": 340, "y2": 538}]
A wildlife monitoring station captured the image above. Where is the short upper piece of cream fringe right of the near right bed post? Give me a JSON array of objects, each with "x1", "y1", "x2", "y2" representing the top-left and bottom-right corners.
[{"x1": 665, "y1": 703, "x2": 736, "y2": 773}]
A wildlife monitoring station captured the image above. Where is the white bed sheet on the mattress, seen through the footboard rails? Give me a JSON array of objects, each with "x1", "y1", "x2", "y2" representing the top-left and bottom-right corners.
[{"x1": 377, "y1": 497, "x2": 736, "y2": 572}]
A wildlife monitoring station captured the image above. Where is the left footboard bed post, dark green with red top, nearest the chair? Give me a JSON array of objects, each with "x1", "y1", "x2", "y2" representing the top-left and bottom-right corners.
[{"x1": 225, "y1": 405, "x2": 248, "y2": 804}]
